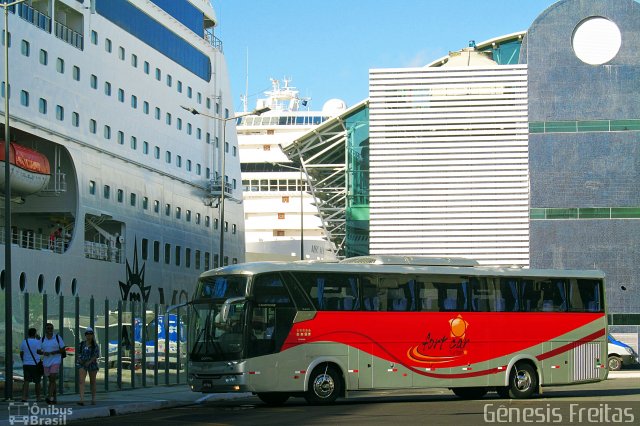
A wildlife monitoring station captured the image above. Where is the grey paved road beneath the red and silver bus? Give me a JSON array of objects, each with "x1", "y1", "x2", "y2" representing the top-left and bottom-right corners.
[{"x1": 73, "y1": 378, "x2": 640, "y2": 426}]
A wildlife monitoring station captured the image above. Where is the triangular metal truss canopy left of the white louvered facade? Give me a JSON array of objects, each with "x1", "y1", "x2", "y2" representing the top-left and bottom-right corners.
[{"x1": 282, "y1": 99, "x2": 369, "y2": 257}]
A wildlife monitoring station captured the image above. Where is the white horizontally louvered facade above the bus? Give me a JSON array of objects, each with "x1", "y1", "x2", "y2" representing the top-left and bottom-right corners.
[{"x1": 369, "y1": 65, "x2": 529, "y2": 266}]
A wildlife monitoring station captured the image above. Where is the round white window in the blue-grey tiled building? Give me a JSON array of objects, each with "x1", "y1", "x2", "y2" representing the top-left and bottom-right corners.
[{"x1": 571, "y1": 16, "x2": 622, "y2": 65}]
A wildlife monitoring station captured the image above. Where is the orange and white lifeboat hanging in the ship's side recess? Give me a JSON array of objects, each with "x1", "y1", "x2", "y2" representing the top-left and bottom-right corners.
[{"x1": 0, "y1": 141, "x2": 51, "y2": 195}]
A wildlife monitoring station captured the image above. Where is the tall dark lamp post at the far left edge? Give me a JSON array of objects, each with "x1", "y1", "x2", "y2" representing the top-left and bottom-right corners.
[{"x1": 0, "y1": 0, "x2": 26, "y2": 400}]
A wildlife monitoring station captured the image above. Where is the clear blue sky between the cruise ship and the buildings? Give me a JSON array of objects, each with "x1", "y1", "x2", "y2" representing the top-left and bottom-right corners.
[{"x1": 216, "y1": 0, "x2": 555, "y2": 111}]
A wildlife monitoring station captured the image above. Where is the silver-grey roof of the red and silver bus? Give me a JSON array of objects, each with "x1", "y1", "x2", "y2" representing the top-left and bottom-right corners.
[{"x1": 200, "y1": 257, "x2": 605, "y2": 279}]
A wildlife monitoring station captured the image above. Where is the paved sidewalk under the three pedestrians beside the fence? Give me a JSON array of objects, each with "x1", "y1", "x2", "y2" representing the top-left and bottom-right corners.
[{"x1": 0, "y1": 385, "x2": 251, "y2": 426}]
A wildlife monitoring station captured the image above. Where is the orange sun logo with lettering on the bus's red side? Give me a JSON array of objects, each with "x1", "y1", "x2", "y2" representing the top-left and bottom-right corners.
[{"x1": 407, "y1": 315, "x2": 470, "y2": 364}]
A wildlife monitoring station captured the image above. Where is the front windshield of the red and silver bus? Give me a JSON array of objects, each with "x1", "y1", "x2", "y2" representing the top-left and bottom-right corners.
[{"x1": 188, "y1": 297, "x2": 246, "y2": 361}]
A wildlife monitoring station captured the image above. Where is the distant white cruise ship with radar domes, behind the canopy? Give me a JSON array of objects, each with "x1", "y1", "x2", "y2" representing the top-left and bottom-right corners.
[{"x1": 237, "y1": 79, "x2": 346, "y2": 261}]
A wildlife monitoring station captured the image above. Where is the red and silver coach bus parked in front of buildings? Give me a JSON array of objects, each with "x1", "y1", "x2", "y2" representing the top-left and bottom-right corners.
[{"x1": 188, "y1": 256, "x2": 608, "y2": 405}]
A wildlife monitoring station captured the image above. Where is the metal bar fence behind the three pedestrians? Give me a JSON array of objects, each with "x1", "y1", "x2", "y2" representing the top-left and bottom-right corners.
[{"x1": 0, "y1": 293, "x2": 188, "y2": 395}]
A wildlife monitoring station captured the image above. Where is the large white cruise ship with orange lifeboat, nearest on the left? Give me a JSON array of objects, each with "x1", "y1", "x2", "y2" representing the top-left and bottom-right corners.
[{"x1": 0, "y1": 0, "x2": 245, "y2": 304}]
